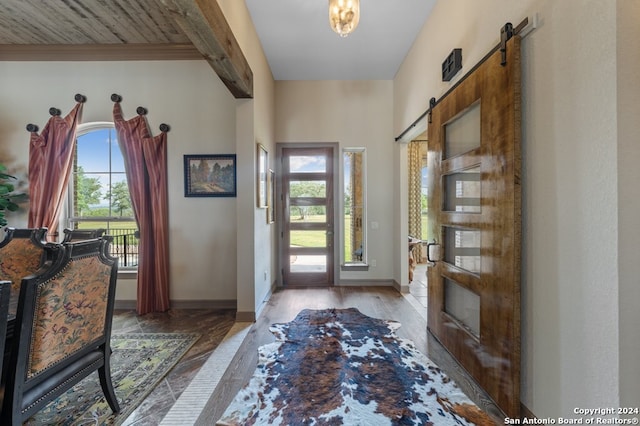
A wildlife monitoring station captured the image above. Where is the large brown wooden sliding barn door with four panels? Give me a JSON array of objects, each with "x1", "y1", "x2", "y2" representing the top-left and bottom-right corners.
[{"x1": 428, "y1": 32, "x2": 521, "y2": 418}]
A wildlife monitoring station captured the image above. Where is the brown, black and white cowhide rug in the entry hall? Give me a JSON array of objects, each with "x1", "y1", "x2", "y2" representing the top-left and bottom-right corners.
[{"x1": 217, "y1": 308, "x2": 494, "y2": 426}]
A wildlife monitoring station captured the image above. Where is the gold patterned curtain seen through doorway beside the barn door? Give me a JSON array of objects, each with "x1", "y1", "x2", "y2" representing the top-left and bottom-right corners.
[{"x1": 408, "y1": 141, "x2": 422, "y2": 262}]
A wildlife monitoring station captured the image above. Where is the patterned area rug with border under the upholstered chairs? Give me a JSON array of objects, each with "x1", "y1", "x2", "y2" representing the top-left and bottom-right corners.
[{"x1": 25, "y1": 333, "x2": 200, "y2": 425}]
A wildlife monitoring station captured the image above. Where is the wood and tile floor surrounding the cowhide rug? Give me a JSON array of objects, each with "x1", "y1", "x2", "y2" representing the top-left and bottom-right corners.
[{"x1": 113, "y1": 265, "x2": 503, "y2": 426}]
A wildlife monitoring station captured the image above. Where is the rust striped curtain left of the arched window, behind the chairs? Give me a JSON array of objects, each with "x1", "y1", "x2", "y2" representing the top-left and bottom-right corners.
[{"x1": 28, "y1": 102, "x2": 83, "y2": 240}]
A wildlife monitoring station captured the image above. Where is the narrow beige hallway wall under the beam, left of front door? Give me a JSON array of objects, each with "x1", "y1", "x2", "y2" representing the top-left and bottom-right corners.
[{"x1": 218, "y1": 0, "x2": 277, "y2": 318}]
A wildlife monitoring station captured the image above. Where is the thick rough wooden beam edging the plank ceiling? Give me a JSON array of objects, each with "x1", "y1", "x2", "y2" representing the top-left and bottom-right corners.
[{"x1": 158, "y1": 0, "x2": 253, "y2": 98}]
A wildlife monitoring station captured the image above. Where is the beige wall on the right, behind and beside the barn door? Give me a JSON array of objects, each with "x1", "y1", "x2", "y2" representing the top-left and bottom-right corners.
[{"x1": 394, "y1": 0, "x2": 638, "y2": 418}]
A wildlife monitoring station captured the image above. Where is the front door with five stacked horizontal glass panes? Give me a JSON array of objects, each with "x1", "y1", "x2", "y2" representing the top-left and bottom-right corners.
[{"x1": 281, "y1": 147, "x2": 334, "y2": 287}]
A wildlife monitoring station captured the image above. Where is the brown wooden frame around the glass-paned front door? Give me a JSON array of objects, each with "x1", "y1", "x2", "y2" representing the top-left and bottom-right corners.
[{"x1": 275, "y1": 142, "x2": 344, "y2": 287}]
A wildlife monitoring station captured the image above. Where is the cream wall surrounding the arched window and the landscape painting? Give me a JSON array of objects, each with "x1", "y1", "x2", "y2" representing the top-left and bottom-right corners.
[{"x1": 0, "y1": 61, "x2": 236, "y2": 306}]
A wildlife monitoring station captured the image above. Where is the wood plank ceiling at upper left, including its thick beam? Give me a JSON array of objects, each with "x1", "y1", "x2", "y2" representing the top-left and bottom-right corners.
[{"x1": 0, "y1": 0, "x2": 253, "y2": 98}]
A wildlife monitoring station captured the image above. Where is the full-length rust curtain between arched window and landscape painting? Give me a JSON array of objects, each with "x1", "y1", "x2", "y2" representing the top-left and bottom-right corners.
[{"x1": 113, "y1": 102, "x2": 169, "y2": 315}]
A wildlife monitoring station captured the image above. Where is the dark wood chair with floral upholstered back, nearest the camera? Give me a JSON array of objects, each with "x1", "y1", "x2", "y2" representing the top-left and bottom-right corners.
[{"x1": 0, "y1": 238, "x2": 120, "y2": 425}]
